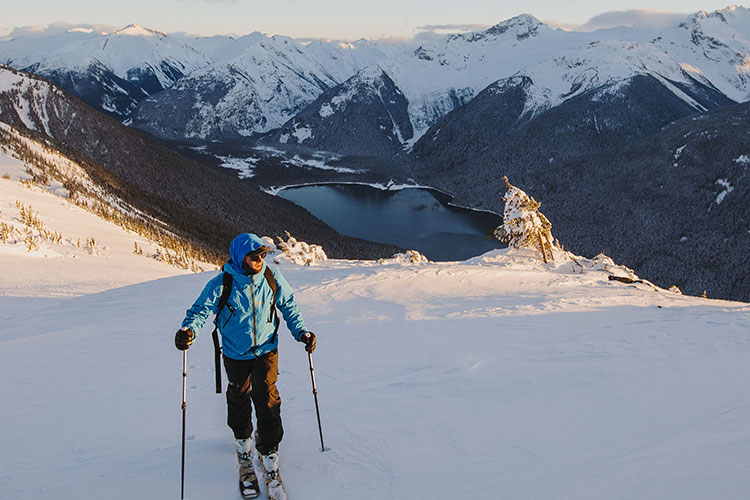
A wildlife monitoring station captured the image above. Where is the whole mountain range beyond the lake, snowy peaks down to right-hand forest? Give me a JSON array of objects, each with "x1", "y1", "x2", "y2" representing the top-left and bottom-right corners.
[{"x1": 0, "y1": 6, "x2": 750, "y2": 300}]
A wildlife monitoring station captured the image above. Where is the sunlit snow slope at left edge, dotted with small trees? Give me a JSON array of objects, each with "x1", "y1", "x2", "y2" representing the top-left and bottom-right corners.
[{"x1": 0, "y1": 131, "x2": 214, "y2": 297}]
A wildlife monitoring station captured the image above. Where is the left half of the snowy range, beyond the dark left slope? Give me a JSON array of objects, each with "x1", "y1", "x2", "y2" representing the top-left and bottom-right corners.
[{"x1": 0, "y1": 24, "x2": 386, "y2": 133}]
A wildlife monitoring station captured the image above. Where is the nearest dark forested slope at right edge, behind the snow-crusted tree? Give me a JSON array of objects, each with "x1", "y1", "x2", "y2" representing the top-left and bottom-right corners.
[{"x1": 415, "y1": 90, "x2": 750, "y2": 300}]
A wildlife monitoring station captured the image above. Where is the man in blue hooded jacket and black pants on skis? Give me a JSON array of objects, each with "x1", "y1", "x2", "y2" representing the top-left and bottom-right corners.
[{"x1": 175, "y1": 233, "x2": 315, "y2": 499}]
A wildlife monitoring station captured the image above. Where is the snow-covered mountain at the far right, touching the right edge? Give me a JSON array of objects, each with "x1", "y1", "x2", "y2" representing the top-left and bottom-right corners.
[{"x1": 506, "y1": 7, "x2": 750, "y2": 117}]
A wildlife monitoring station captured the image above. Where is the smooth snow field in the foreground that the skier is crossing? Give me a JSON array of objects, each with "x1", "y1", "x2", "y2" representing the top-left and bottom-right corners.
[{"x1": 0, "y1": 212, "x2": 750, "y2": 500}]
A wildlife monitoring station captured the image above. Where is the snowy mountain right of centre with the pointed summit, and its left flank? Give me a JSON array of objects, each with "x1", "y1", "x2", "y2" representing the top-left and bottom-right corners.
[{"x1": 280, "y1": 15, "x2": 585, "y2": 154}]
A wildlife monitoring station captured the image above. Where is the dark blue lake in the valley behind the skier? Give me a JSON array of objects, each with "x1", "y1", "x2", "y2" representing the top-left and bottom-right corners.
[{"x1": 278, "y1": 184, "x2": 505, "y2": 261}]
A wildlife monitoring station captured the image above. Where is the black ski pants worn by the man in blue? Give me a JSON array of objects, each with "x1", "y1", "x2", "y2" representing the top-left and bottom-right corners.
[{"x1": 224, "y1": 350, "x2": 284, "y2": 455}]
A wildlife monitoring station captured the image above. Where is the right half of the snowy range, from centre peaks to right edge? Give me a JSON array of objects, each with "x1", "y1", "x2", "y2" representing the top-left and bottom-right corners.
[{"x1": 277, "y1": 7, "x2": 750, "y2": 155}]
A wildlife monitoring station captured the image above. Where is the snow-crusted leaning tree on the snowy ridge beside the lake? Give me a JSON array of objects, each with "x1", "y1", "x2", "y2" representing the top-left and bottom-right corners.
[{"x1": 495, "y1": 177, "x2": 555, "y2": 262}]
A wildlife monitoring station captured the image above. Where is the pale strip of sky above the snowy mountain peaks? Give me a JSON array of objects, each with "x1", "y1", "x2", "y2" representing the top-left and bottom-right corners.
[{"x1": 0, "y1": 0, "x2": 744, "y2": 40}]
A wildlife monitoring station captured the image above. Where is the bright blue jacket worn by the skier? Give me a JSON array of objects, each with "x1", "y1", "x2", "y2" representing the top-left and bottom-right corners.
[{"x1": 182, "y1": 258, "x2": 307, "y2": 359}]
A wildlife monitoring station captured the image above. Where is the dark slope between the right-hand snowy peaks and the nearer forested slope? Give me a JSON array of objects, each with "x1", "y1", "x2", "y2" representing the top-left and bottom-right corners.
[{"x1": 413, "y1": 75, "x2": 733, "y2": 182}]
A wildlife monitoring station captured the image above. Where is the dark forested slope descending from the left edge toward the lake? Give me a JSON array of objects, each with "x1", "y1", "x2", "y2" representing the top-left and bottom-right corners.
[{"x1": 0, "y1": 68, "x2": 397, "y2": 258}]
